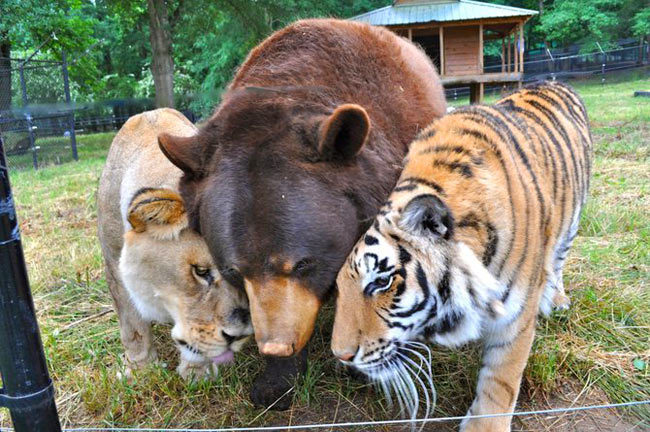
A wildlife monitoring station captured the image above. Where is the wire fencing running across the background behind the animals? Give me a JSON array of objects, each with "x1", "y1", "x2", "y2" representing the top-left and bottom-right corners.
[{"x1": 0, "y1": 40, "x2": 650, "y2": 169}]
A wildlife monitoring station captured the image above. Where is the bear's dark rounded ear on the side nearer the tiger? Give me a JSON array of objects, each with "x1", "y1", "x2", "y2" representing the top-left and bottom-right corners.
[{"x1": 318, "y1": 104, "x2": 370, "y2": 160}]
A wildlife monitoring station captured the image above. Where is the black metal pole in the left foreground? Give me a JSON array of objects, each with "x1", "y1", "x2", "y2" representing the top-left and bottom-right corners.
[{"x1": 0, "y1": 138, "x2": 61, "y2": 432}]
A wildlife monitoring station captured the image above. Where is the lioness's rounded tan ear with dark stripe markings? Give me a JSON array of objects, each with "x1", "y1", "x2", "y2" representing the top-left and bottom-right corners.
[{"x1": 127, "y1": 188, "x2": 188, "y2": 240}]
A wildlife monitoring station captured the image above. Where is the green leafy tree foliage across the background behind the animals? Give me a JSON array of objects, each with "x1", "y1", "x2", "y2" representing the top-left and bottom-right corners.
[{"x1": 0, "y1": 0, "x2": 650, "y2": 115}]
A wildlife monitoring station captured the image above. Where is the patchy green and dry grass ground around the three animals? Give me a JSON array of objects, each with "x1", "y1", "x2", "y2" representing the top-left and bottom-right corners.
[{"x1": 0, "y1": 71, "x2": 650, "y2": 430}]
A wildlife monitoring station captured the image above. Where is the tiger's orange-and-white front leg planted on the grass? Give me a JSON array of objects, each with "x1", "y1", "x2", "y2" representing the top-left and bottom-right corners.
[{"x1": 460, "y1": 310, "x2": 537, "y2": 432}]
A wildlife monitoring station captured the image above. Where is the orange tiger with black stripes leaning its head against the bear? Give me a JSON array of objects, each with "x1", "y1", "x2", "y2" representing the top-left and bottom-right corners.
[{"x1": 331, "y1": 82, "x2": 592, "y2": 432}]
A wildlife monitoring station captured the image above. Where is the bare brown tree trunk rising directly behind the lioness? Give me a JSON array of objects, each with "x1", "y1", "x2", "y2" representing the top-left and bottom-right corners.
[{"x1": 147, "y1": 0, "x2": 174, "y2": 108}]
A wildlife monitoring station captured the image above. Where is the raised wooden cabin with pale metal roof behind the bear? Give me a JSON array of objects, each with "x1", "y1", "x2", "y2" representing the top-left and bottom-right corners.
[{"x1": 351, "y1": 0, "x2": 537, "y2": 103}]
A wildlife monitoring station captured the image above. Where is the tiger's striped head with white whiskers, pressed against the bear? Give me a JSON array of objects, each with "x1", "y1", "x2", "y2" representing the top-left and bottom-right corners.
[{"x1": 332, "y1": 184, "x2": 503, "y2": 380}]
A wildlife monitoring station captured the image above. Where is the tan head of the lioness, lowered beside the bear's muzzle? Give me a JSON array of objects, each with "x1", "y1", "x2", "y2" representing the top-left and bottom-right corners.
[{"x1": 119, "y1": 188, "x2": 253, "y2": 363}]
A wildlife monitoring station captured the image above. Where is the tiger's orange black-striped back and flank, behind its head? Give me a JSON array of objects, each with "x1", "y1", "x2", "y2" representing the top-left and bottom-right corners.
[{"x1": 398, "y1": 82, "x2": 592, "y2": 315}]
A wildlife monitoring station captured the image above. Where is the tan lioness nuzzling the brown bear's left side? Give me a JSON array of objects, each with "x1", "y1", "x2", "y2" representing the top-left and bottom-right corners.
[{"x1": 97, "y1": 109, "x2": 253, "y2": 379}]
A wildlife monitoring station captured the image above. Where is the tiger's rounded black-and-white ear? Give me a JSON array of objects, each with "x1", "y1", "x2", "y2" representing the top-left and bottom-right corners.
[{"x1": 399, "y1": 194, "x2": 454, "y2": 240}]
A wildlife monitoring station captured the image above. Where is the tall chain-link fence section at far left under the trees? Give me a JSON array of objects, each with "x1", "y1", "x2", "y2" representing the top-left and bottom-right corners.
[{"x1": 0, "y1": 53, "x2": 78, "y2": 169}]
